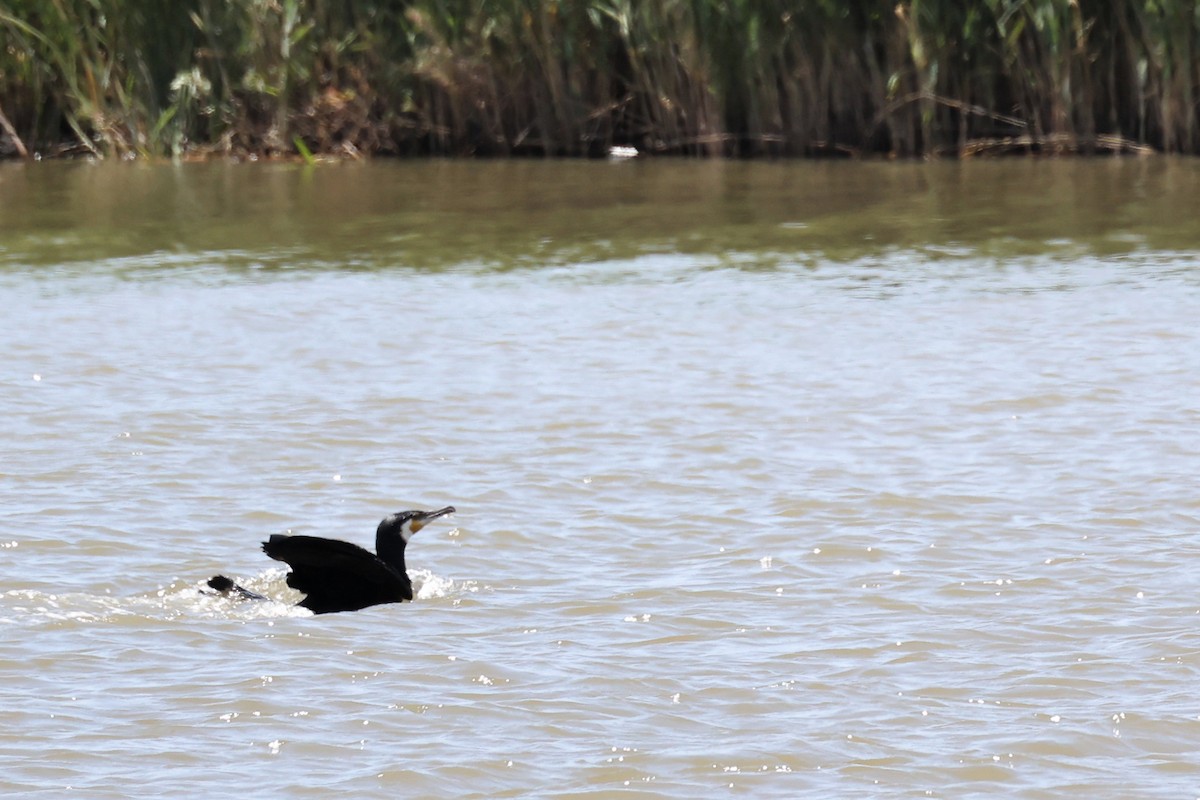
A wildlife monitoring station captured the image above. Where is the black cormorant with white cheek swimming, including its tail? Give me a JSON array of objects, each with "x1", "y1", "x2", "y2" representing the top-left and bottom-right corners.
[{"x1": 209, "y1": 506, "x2": 454, "y2": 614}]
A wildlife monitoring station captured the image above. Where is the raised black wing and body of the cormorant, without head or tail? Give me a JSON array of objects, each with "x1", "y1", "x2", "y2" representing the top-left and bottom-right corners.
[{"x1": 263, "y1": 534, "x2": 413, "y2": 614}]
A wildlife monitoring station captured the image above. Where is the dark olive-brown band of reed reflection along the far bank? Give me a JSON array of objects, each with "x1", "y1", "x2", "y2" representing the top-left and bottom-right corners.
[{"x1": 0, "y1": 158, "x2": 1200, "y2": 270}]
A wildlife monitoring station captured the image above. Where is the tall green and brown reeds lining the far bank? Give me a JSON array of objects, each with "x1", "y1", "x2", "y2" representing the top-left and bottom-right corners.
[{"x1": 0, "y1": 0, "x2": 1200, "y2": 161}]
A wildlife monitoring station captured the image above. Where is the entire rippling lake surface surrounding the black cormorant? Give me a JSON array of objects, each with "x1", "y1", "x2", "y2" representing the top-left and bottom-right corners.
[{"x1": 0, "y1": 158, "x2": 1200, "y2": 799}]
